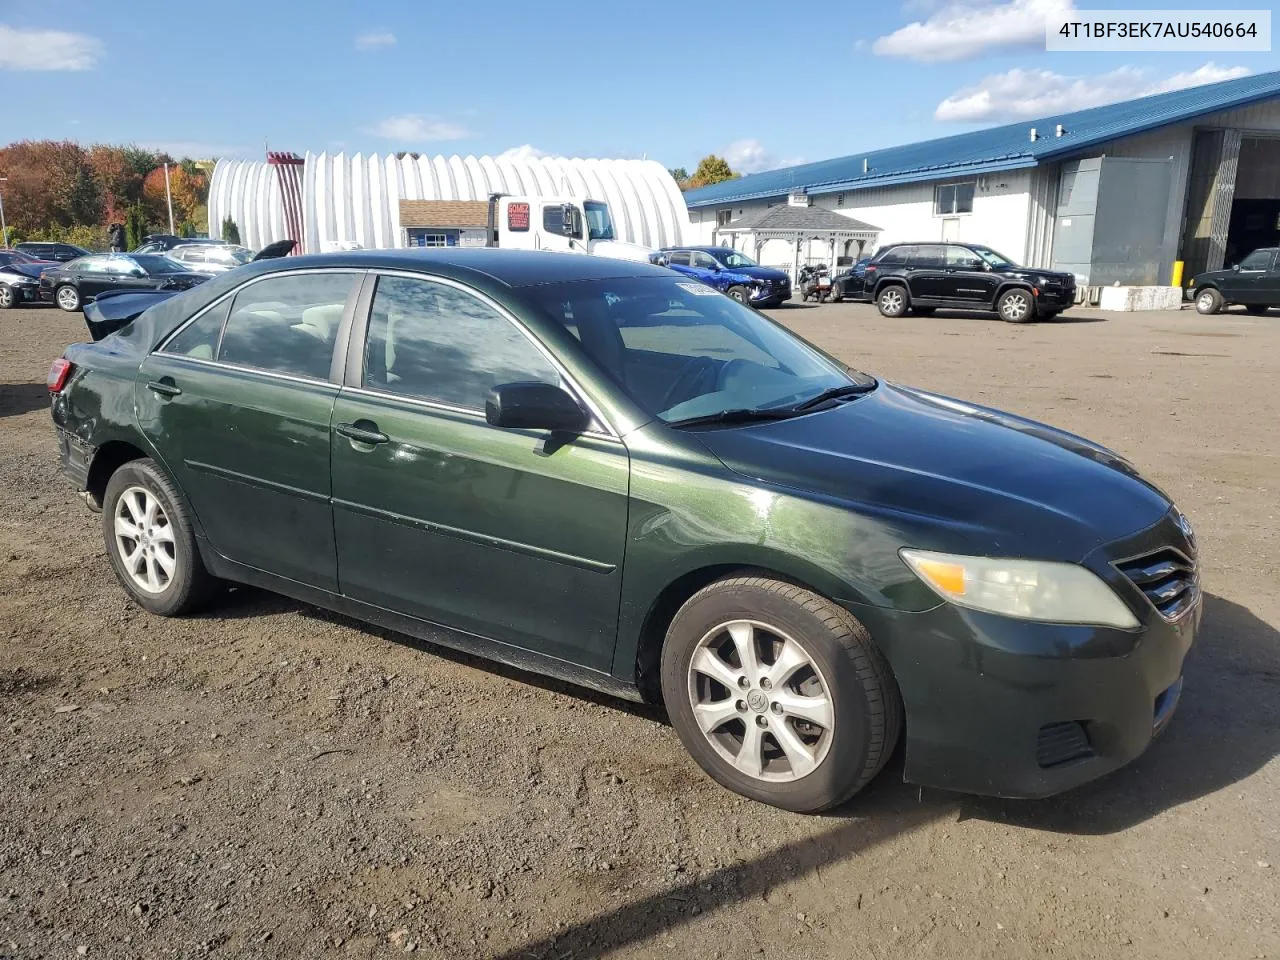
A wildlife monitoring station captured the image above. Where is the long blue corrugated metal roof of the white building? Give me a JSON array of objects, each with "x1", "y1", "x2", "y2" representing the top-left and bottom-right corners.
[{"x1": 685, "y1": 72, "x2": 1280, "y2": 207}]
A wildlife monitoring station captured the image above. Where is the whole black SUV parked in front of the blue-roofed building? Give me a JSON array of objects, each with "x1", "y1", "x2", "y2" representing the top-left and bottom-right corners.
[{"x1": 854, "y1": 243, "x2": 1075, "y2": 324}]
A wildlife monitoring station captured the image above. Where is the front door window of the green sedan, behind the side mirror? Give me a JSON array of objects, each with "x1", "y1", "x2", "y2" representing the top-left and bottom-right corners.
[{"x1": 364, "y1": 276, "x2": 559, "y2": 410}]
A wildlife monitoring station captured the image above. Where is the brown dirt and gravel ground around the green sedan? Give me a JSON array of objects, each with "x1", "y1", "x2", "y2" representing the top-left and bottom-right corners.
[{"x1": 0, "y1": 296, "x2": 1280, "y2": 960}]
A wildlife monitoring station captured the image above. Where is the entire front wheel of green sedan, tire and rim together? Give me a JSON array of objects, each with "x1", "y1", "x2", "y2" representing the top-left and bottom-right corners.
[{"x1": 662, "y1": 576, "x2": 902, "y2": 813}]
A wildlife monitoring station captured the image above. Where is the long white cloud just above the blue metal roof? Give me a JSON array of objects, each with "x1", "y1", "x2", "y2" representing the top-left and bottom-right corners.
[{"x1": 933, "y1": 63, "x2": 1251, "y2": 123}]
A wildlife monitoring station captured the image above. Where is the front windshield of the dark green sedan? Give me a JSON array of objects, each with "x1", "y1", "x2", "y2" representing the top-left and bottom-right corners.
[{"x1": 529, "y1": 276, "x2": 874, "y2": 422}]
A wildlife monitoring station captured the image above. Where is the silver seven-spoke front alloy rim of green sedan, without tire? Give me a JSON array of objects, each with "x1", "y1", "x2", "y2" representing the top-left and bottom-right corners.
[{"x1": 689, "y1": 620, "x2": 836, "y2": 783}]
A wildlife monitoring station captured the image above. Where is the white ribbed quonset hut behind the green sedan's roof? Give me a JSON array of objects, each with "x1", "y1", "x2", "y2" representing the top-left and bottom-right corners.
[{"x1": 209, "y1": 154, "x2": 689, "y2": 253}]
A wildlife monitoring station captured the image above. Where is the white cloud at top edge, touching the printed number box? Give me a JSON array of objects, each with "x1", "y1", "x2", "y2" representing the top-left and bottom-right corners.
[{"x1": 872, "y1": 0, "x2": 1075, "y2": 63}]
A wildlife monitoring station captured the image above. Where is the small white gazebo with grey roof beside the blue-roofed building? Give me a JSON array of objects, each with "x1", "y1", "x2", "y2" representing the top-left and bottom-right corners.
[{"x1": 713, "y1": 193, "x2": 879, "y2": 280}]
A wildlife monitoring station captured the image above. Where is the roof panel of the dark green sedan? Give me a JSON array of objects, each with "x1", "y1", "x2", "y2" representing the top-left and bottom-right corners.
[{"x1": 237, "y1": 247, "x2": 672, "y2": 287}]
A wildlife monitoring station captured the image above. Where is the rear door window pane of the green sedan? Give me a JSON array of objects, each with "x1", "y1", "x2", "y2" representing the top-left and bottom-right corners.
[{"x1": 218, "y1": 273, "x2": 355, "y2": 380}]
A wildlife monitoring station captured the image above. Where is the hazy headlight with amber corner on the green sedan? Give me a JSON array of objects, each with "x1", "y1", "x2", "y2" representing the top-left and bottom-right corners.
[{"x1": 901, "y1": 549, "x2": 1138, "y2": 630}]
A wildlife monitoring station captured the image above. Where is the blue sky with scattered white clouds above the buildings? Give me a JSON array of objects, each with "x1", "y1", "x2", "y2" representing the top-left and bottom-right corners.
[{"x1": 0, "y1": 0, "x2": 1280, "y2": 173}]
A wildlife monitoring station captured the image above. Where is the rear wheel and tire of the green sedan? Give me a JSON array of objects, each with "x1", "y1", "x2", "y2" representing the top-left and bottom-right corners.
[{"x1": 102, "y1": 460, "x2": 216, "y2": 617}]
